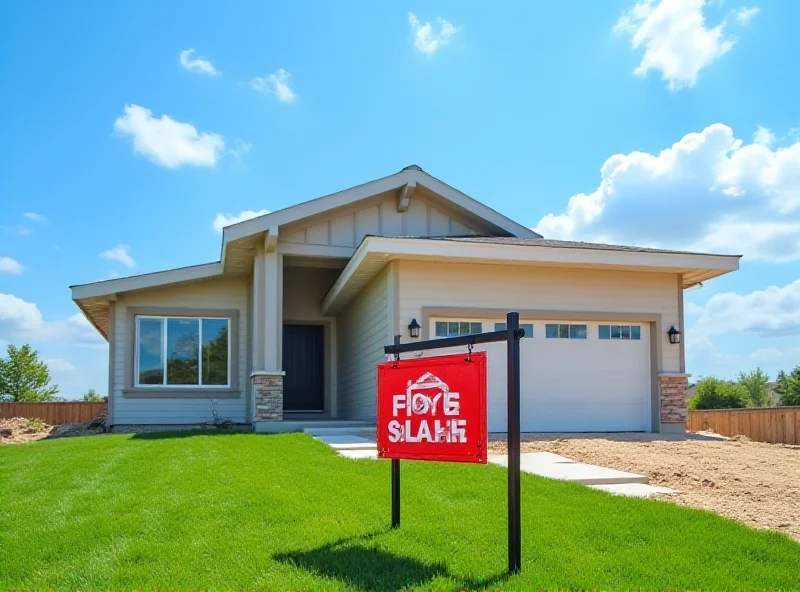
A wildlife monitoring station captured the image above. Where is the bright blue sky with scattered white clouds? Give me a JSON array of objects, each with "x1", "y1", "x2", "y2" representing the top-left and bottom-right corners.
[{"x1": 0, "y1": 0, "x2": 800, "y2": 398}]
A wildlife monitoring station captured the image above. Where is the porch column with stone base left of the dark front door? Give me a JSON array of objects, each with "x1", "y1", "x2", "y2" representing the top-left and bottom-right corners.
[{"x1": 251, "y1": 227, "x2": 284, "y2": 421}]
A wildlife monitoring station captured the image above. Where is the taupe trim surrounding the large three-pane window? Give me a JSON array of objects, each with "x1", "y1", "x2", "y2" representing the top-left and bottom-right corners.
[{"x1": 123, "y1": 306, "x2": 242, "y2": 399}]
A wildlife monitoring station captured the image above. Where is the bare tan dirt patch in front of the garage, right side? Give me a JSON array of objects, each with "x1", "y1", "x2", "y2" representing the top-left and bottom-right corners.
[{"x1": 489, "y1": 434, "x2": 800, "y2": 541}]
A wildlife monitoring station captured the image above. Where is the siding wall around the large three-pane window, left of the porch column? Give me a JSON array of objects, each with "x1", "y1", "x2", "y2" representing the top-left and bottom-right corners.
[{"x1": 111, "y1": 278, "x2": 249, "y2": 425}]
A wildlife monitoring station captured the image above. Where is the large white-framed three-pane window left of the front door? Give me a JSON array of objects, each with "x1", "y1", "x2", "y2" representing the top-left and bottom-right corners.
[{"x1": 134, "y1": 315, "x2": 231, "y2": 388}]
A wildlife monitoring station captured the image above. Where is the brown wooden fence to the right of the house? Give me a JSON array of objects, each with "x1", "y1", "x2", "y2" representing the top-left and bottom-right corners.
[{"x1": 686, "y1": 407, "x2": 800, "y2": 444}]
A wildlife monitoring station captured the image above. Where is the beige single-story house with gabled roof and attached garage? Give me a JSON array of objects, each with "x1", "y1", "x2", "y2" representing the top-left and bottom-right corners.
[{"x1": 72, "y1": 166, "x2": 739, "y2": 432}]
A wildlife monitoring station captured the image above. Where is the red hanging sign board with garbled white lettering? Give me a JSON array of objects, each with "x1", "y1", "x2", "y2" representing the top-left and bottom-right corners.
[{"x1": 377, "y1": 352, "x2": 487, "y2": 464}]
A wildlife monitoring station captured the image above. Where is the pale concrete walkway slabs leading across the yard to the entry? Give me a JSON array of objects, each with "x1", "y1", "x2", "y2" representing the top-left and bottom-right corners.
[{"x1": 313, "y1": 433, "x2": 676, "y2": 497}]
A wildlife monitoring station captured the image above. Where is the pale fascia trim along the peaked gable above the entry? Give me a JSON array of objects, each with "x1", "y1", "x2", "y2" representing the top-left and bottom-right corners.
[{"x1": 221, "y1": 165, "x2": 541, "y2": 270}]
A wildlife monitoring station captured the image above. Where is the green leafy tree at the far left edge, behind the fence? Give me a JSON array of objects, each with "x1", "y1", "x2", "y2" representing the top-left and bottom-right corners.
[{"x1": 0, "y1": 344, "x2": 58, "y2": 403}]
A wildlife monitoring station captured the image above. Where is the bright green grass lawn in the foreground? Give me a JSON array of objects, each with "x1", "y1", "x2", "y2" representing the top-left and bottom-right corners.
[{"x1": 0, "y1": 434, "x2": 800, "y2": 590}]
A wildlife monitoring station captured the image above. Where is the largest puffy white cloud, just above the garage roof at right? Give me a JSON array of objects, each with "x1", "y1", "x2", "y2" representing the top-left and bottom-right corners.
[{"x1": 536, "y1": 123, "x2": 800, "y2": 262}]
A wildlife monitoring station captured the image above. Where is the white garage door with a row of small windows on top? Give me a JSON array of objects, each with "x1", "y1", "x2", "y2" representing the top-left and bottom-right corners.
[{"x1": 431, "y1": 318, "x2": 651, "y2": 432}]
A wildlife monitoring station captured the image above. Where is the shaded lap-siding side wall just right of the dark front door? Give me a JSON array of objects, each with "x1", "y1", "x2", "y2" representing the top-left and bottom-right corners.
[{"x1": 337, "y1": 268, "x2": 389, "y2": 420}]
